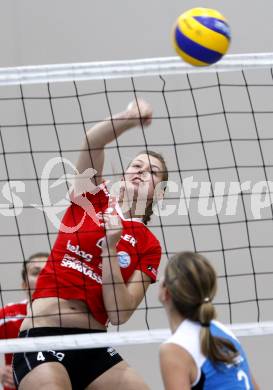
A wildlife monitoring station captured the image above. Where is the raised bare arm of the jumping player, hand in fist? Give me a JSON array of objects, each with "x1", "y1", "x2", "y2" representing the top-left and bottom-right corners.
[{"x1": 77, "y1": 99, "x2": 152, "y2": 185}]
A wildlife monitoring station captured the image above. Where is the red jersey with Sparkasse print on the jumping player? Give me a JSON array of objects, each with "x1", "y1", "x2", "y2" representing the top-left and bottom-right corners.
[{"x1": 32, "y1": 184, "x2": 161, "y2": 325}]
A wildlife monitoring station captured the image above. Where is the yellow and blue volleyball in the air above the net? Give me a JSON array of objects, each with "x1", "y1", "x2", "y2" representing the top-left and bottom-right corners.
[{"x1": 173, "y1": 8, "x2": 231, "y2": 66}]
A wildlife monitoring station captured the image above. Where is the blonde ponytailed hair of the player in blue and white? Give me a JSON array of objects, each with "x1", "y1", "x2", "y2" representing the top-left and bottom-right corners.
[{"x1": 165, "y1": 252, "x2": 238, "y2": 364}]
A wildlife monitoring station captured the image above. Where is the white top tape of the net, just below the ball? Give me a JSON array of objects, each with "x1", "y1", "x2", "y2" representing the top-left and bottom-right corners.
[{"x1": 0, "y1": 53, "x2": 273, "y2": 85}]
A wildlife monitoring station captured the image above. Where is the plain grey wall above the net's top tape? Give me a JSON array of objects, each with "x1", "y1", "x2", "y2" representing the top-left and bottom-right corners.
[{"x1": 0, "y1": 0, "x2": 273, "y2": 66}]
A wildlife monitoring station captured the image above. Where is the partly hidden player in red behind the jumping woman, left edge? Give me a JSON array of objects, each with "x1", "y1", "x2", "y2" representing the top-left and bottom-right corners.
[{"x1": 0, "y1": 252, "x2": 48, "y2": 390}]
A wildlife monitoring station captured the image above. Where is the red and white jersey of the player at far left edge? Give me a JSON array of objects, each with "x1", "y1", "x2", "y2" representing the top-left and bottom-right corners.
[{"x1": 0, "y1": 300, "x2": 28, "y2": 380}]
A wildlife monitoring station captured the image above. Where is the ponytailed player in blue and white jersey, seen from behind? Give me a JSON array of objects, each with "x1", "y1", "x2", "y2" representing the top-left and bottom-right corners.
[{"x1": 159, "y1": 252, "x2": 259, "y2": 390}]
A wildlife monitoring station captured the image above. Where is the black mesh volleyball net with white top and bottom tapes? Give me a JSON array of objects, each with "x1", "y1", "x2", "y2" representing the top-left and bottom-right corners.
[{"x1": 0, "y1": 54, "x2": 273, "y2": 352}]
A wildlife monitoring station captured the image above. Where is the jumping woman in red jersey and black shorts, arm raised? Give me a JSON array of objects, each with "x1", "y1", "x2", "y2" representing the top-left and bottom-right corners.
[{"x1": 14, "y1": 100, "x2": 168, "y2": 390}]
